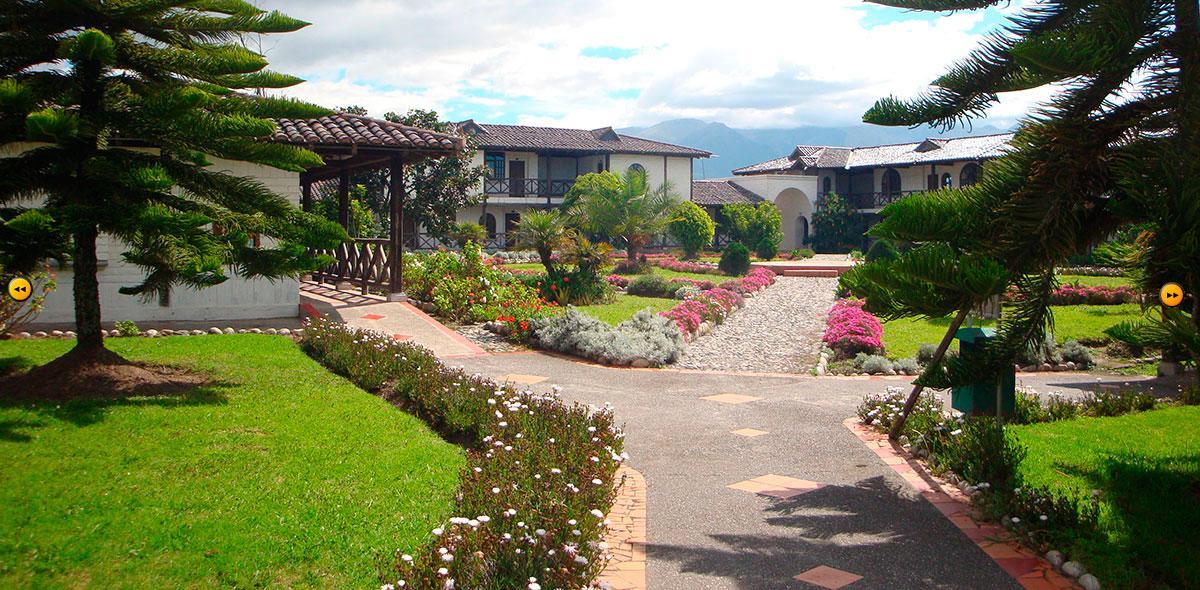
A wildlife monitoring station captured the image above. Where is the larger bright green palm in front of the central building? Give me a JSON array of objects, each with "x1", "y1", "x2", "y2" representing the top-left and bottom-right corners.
[{"x1": 563, "y1": 168, "x2": 679, "y2": 260}]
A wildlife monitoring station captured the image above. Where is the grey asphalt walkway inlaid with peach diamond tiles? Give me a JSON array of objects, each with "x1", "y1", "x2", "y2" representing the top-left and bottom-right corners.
[{"x1": 454, "y1": 353, "x2": 1132, "y2": 590}]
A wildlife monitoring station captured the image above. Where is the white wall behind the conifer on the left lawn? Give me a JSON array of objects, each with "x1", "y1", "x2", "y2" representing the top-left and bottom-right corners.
[{"x1": 0, "y1": 144, "x2": 300, "y2": 325}]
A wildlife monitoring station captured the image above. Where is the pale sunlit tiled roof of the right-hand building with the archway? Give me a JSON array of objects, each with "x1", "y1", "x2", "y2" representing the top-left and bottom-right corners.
[{"x1": 733, "y1": 133, "x2": 1013, "y2": 175}]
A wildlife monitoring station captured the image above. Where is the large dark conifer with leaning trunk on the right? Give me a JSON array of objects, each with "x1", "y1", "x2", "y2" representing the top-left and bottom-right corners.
[{"x1": 844, "y1": 0, "x2": 1200, "y2": 434}]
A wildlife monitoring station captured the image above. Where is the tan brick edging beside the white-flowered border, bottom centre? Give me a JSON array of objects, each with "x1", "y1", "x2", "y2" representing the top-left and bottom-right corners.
[{"x1": 595, "y1": 465, "x2": 646, "y2": 590}]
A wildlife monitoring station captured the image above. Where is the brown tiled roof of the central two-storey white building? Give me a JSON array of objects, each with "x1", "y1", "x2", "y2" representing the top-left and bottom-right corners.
[{"x1": 457, "y1": 120, "x2": 712, "y2": 158}]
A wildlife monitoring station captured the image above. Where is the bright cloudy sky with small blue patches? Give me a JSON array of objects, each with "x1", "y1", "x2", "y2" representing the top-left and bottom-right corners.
[{"x1": 258, "y1": 0, "x2": 1045, "y2": 128}]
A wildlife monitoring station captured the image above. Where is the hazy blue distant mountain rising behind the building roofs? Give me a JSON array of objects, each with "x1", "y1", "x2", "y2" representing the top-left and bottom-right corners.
[{"x1": 617, "y1": 119, "x2": 1008, "y2": 179}]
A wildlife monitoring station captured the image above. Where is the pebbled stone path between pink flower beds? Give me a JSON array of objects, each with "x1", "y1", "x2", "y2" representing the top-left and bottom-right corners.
[{"x1": 677, "y1": 277, "x2": 838, "y2": 373}]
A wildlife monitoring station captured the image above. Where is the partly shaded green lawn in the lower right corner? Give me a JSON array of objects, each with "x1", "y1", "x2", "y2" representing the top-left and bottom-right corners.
[{"x1": 1013, "y1": 407, "x2": 1200, "y2": 588}]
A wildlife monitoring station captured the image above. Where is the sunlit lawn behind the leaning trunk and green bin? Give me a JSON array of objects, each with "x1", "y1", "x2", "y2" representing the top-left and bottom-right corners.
[{"x1": 883, "y1": 303, "x2": 1141, "y2": 359}]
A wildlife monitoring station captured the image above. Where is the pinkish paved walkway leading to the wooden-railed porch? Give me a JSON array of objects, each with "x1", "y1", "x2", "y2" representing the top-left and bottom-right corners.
[{"x1": 300, "y1": 283, "x2": 486, "y2": 359}]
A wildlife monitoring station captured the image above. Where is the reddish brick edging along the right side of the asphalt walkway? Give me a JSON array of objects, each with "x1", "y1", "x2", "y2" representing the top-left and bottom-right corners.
[{"x1": 842, "y1": 419, "x2": 1080, "y2": 590}]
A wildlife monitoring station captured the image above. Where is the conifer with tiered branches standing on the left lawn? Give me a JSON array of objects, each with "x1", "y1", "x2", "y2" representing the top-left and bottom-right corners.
[{"x1": 0, "y1": 0, "x2": 346, "y2": 362}]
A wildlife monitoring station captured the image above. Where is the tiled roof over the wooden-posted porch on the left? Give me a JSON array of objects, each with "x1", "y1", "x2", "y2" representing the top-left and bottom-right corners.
[{"x1": 271, "y1": 113, "x2": 466, "y2": 151}]
